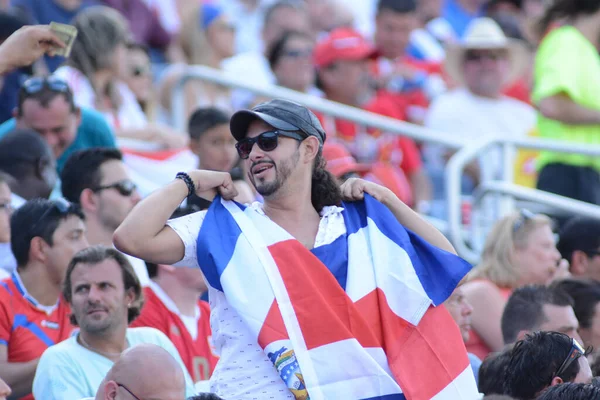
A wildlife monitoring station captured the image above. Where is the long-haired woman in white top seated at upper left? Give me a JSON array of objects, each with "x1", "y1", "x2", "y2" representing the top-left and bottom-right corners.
[{"x1": 55, "y1": 6, "x2": 185, "y2": 148}]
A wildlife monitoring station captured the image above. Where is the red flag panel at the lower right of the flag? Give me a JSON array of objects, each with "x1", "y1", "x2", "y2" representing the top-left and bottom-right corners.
[{"x1": 380, "y1": 306, "x2": 469, "y2": 400}]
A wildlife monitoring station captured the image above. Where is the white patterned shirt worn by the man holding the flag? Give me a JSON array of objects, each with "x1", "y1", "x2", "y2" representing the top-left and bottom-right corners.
[{"x1": 167, "y1": 202, "x2": 346, "y2": 400}]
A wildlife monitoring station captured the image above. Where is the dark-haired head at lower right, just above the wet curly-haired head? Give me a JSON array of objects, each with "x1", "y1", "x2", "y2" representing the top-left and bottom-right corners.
[{"x1": 502, "y1": 285, "x2": 581, "y2": 344}]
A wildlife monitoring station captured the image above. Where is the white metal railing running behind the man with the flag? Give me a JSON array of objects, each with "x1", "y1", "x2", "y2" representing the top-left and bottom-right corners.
[{"x1": 171, "y1": 66, "x2": 600, "y2": 262}]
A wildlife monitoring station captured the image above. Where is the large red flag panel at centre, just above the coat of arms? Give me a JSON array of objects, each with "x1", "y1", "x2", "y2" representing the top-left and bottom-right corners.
[{"x1": 269, "y1": 240, "x2": 381, "y2": 350}]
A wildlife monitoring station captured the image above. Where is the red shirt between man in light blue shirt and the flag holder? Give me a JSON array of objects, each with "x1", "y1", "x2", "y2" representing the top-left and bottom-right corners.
[{"x1": 131, "y1": 287, "x2": 219, "y2": 382}]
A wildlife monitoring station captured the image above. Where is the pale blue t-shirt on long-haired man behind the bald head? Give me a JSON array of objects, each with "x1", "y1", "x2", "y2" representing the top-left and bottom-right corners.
[{"x1": 33, "y1": 328, "x2": 195, "y2": 400}]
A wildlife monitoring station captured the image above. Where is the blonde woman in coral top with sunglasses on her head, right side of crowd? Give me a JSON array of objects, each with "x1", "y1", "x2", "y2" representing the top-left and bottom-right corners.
[{"x1": 463, "y1": 210, "x2": 565, "y2": 360}]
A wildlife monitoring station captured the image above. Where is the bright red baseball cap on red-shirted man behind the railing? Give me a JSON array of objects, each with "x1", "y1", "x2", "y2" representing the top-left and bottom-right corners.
[{"x1": 314, "y1": 28, "x2": 377, "y2": 68}]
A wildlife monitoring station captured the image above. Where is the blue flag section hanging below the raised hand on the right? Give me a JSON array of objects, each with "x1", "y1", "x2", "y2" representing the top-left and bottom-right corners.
[{"x1": 344, "y1": 195, "x2": 471, "y2": 306}]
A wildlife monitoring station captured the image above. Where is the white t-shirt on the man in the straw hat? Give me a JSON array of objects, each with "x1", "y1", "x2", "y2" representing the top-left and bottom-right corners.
[{"x1": 424, "y1": 88, "x2": 536, "y2": 181}]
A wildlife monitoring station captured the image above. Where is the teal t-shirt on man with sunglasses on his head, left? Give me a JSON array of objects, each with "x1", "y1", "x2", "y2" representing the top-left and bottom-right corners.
[{"x1": 0, "y1": 108, "x2": 117, "y2": 173}]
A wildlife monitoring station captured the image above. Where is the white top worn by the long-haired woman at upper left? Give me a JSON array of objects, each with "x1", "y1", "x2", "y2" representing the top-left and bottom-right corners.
[{"x1": 54, "y1": 65, "x2": 148, "y2": 129}]
